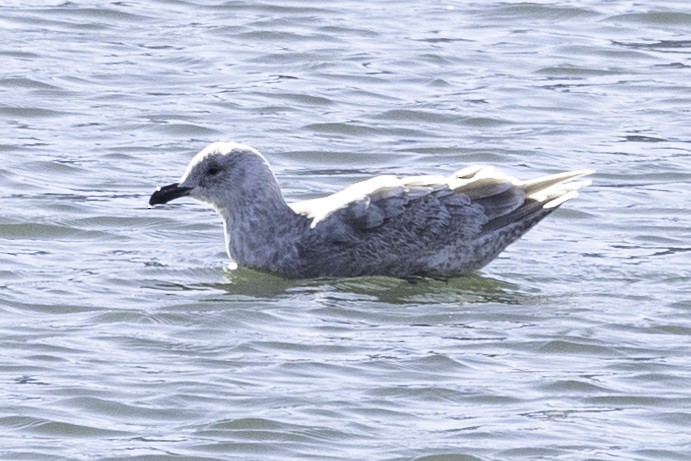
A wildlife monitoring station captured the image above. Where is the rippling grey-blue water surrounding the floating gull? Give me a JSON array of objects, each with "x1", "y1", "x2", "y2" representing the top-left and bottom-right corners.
[{"x1": 0, "y1": 0, "x2": 691, "y2": 461}]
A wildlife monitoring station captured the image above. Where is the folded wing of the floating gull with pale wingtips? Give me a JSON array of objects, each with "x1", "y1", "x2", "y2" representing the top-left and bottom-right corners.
[{"x1": 291, "y1": 166, "x2": 592, "y2": 236}]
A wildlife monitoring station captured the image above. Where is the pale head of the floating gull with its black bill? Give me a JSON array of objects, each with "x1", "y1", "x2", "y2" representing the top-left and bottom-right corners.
[{"x1": 149, "y1": 142, "x2": 280, "y2": 210}]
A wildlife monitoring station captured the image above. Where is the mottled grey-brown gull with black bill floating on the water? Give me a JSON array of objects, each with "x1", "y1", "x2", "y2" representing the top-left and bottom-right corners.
[{"x1": 149, "y1": 142, "x2": 592, "y2": 278}]
